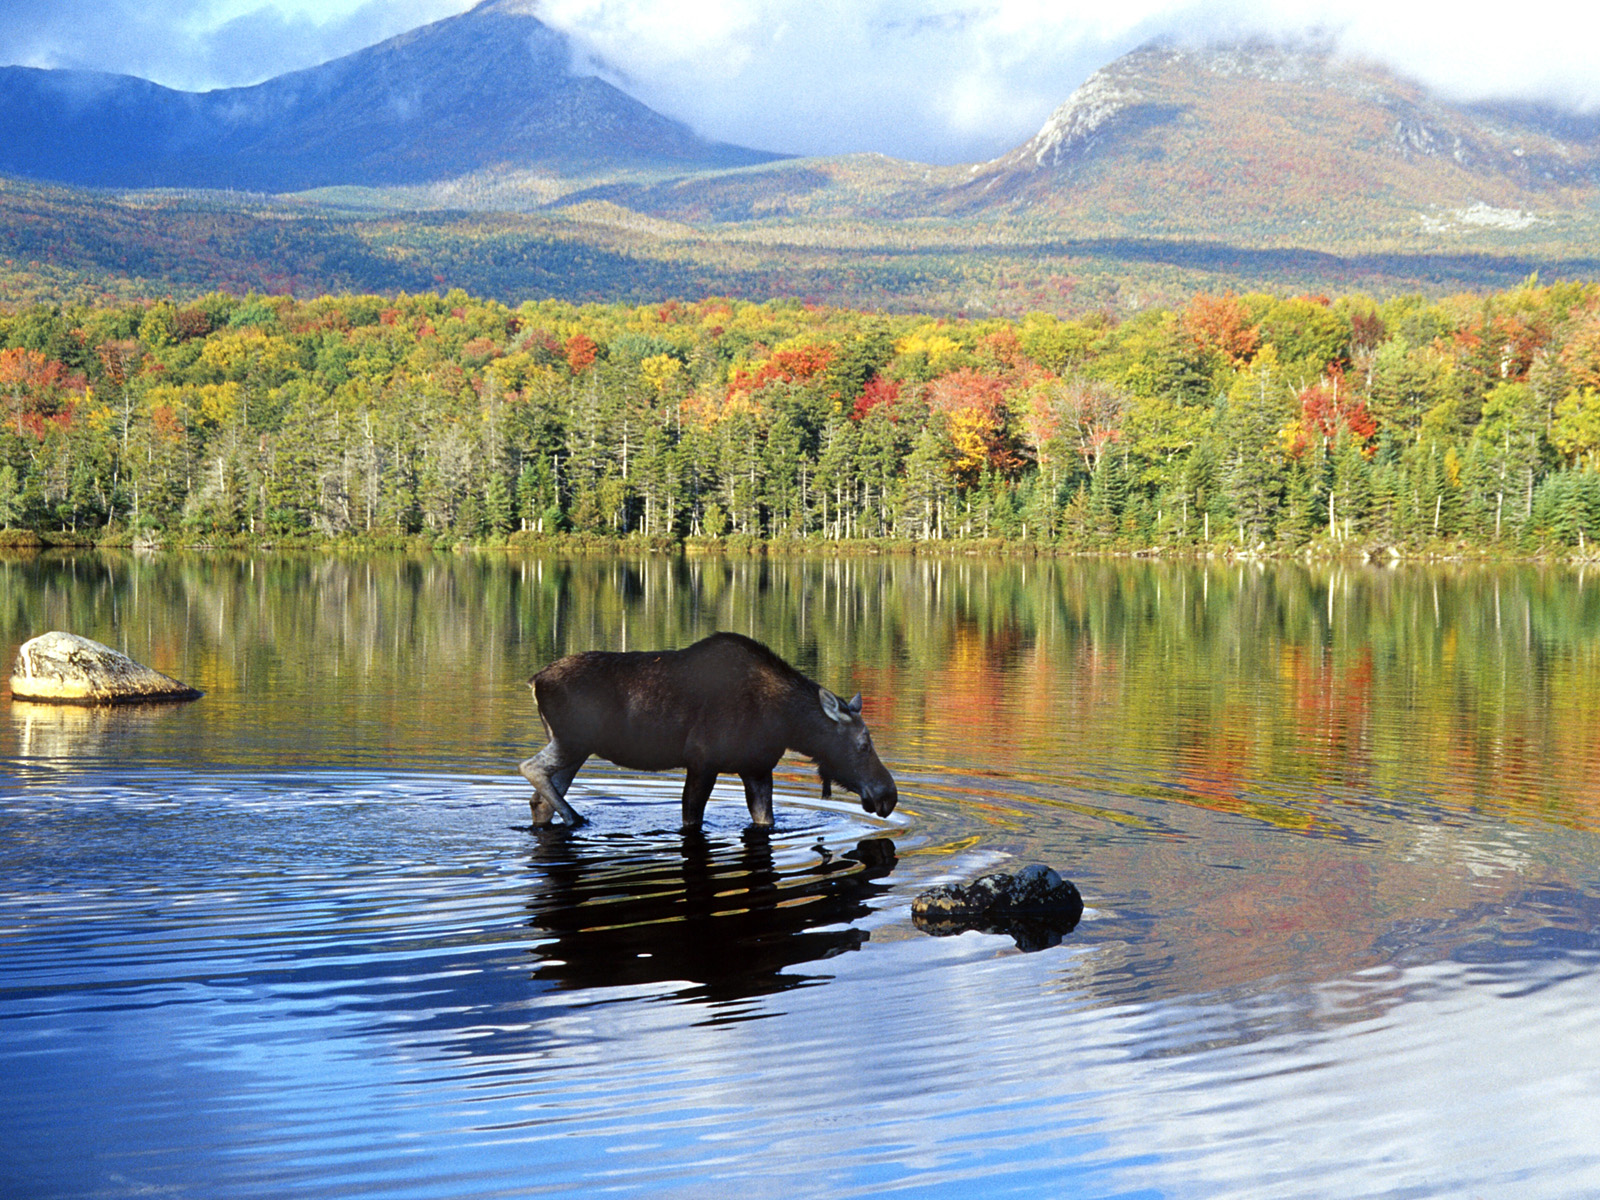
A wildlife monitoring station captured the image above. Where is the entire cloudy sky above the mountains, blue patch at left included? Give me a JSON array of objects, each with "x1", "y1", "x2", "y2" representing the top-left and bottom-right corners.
[{"x1": 0, "y1": 0, "x2": 1600, "y2": 163}]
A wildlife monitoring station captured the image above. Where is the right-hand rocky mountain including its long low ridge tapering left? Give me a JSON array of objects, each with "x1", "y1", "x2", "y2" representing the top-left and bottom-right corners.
[{"x1": 534, "y1": 43, "x2": 1600, "y2": 253}]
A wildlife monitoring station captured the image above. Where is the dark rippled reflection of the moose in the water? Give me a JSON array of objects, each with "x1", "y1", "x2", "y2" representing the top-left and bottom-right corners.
[{"x1": 530, "y1": 827, "x2": 898, "y2": 1005}]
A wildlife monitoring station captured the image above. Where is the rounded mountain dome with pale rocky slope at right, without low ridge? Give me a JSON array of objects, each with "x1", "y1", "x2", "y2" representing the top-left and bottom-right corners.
[{"x1": 942, "y1": 43, "x2": 1600, "y2": 240}]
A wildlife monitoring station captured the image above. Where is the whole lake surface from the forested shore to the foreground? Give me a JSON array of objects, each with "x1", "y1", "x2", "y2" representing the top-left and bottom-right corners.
[{"x1": 0, "y1": 554, "x2": 1600, "y2": 1200}]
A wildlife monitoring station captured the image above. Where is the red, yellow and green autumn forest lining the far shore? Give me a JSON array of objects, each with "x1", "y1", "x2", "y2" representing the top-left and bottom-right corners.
[{"x1": 0, "y1": 277, "x2": 1600, "y2": 555}]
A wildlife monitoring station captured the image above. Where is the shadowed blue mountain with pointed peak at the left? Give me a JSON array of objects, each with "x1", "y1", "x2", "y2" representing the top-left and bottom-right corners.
[{"x1": 0, "y1": 0, "x2": 779, "y2": 192}]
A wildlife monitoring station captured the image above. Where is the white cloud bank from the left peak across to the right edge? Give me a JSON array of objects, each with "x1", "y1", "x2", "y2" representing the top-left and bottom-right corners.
[{"x1": 542, "y1": 0, "x2": 1600, "y2": 162}]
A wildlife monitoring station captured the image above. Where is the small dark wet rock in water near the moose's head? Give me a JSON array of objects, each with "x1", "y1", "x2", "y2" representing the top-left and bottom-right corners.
[{"x1": 910, "y1": 864, "x2": 1083, "y2": 950}]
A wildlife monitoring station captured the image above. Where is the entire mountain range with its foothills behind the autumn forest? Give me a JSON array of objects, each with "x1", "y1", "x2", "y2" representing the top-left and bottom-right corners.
[{"x1": 0, "y1": 33, "x2": 1600, "y2": 314}]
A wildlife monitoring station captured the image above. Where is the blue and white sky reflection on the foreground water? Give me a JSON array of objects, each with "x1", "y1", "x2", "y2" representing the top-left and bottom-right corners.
[{"x1": 0, "y1": 781, "x2": 1600, "y2": 1200}]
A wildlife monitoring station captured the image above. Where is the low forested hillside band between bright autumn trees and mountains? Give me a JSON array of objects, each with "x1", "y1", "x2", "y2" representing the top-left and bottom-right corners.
[{"x1": 18, "y1": 179, "x2": 1600, "y2": 317}]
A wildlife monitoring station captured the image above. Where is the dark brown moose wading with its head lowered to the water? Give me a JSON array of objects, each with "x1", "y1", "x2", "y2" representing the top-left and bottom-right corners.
[{"x1": 518, "y1": 634, "x2": 899, "y2": 829}]
